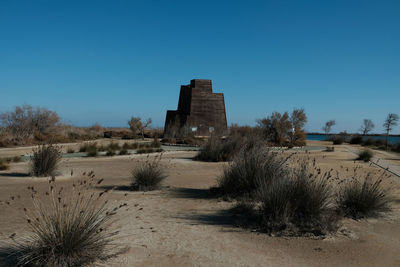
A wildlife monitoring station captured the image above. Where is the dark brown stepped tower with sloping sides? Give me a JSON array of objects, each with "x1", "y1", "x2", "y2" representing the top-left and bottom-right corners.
[{"x1": 164, "y1": 79, "x2": 228, "y2": 137}]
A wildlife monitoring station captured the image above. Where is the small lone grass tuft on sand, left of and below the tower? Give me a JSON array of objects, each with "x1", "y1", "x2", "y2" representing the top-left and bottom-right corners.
[{"x1": 131, "y1": 155, "x2": 167, "y2": 191}]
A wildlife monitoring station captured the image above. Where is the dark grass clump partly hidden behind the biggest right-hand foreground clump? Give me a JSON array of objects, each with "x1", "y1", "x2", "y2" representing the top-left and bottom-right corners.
[{"x1": 218, "y1": 144, "x2": 287, "y2": 198}]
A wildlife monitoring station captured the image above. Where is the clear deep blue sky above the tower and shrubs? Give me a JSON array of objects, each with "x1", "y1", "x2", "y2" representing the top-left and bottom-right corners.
[{"x1": 0, "y1": 0, "x2": 400, "y2": 133}]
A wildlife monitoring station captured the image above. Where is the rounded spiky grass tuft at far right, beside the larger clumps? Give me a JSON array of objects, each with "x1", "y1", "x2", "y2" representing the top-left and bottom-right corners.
[{"x1": 338, "y1": 175, "x2": 392, "y2": 219}]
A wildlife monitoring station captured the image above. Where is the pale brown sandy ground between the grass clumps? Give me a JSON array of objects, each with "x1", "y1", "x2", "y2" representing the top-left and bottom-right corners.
[{"x1": 0, "y1": 142, "x2": 400, "y2": 266}]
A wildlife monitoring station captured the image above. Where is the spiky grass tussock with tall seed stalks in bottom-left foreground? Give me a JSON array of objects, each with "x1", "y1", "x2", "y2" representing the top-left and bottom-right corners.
[{"x1": 1, "y1": 175, "x2": 126, "y2": 267}]
